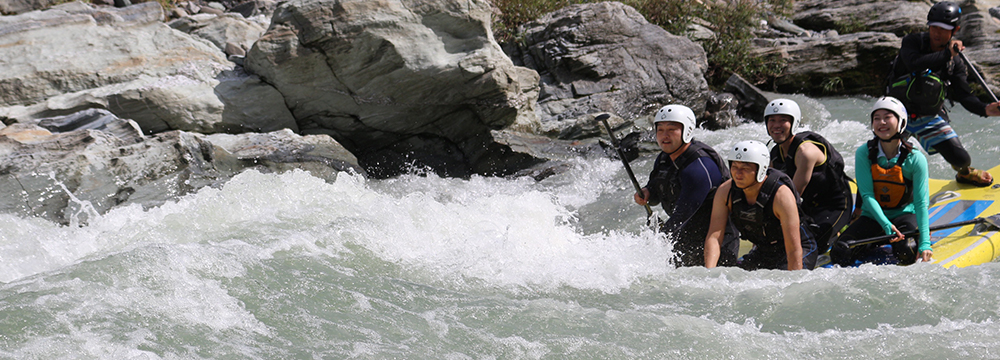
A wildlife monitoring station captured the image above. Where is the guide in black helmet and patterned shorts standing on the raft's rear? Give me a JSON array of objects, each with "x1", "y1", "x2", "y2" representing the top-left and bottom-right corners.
[{"x1": 887, "y1": 1, "x2": 1000, "y2": 186}]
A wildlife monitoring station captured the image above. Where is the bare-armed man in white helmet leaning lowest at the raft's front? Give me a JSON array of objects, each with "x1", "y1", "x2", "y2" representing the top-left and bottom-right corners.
[{"x1": 705, "y1": 140, "x2": 819, "y2": 270}]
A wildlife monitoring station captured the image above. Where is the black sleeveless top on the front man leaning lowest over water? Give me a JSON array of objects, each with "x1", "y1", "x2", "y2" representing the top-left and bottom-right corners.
[{"x1": 729, "y1": 168, "x2": 815, "y2": 254}]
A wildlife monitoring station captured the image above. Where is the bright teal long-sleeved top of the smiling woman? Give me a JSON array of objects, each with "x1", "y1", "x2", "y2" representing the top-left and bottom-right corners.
[{"x1": 854, "y1": 139, "x2": 931, "y2": 252}]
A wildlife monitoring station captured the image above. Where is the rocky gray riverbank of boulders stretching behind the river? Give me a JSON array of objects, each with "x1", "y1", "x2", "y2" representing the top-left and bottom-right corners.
[{"x1": 0, "y1": 0, "x2": 1000, "y2": 224}]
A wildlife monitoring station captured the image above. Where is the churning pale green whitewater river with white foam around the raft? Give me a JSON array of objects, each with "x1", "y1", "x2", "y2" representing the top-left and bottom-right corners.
[{"x1": 0, "y1": 97, "x2": 1000, "y2": 359}]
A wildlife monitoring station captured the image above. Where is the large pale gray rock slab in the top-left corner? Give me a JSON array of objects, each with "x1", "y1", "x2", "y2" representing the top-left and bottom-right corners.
[{"x1": 0, "y1": 2, "x2": 297, "y2": 134}]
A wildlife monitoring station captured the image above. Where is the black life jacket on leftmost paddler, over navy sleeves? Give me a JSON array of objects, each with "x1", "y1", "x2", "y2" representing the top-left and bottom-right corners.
[{"x1": 653, "y1": 141, "x2": 729, "y2": 214}]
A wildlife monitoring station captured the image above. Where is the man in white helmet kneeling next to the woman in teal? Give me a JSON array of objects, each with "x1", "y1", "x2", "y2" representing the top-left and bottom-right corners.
[{"x1": 764, "y1": 99, "x2": 854, "y2": 253}]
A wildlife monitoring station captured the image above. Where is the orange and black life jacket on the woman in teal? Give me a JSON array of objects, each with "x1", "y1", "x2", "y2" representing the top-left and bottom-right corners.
[{"x1": 868, "y1": 138, "x2": 913, "y2": 209}]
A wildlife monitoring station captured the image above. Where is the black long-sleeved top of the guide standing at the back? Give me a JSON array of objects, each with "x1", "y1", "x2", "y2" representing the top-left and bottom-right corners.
[{"x1": 896, "y1": 32, "x2": 988, "y2": 117}]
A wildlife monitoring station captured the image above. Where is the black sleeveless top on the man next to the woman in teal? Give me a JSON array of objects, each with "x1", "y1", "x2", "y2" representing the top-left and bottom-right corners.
[{"x1": 771, "y1": 131, "x2": 853, "y2": 211}]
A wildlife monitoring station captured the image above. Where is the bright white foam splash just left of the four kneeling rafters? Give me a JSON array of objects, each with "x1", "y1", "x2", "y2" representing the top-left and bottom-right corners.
[{"x1": 350, "y1": 170, "x2": 672, "y2": 291}]
